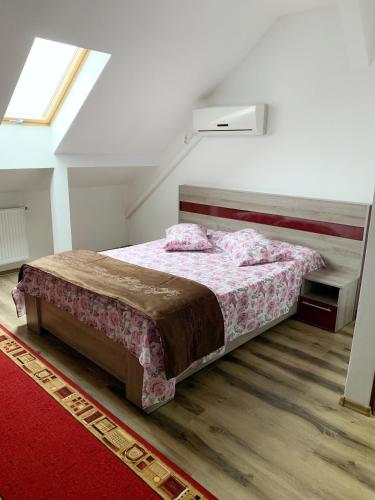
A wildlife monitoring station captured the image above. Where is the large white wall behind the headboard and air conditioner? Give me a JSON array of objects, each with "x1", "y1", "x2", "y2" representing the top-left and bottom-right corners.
[{"x1": 129, "y1": 7, "x2": 375, "y2": 242}]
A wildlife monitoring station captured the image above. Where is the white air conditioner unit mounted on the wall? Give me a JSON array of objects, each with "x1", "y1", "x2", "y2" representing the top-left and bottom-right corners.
[{"x1": 193, "y1": 104, "x2": 267, "y2": 136}]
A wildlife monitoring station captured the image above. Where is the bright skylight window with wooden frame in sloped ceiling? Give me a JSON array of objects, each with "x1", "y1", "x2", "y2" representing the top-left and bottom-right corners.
[{"x1": 4, "y1": 38, "x2": 88, "y2": 125}]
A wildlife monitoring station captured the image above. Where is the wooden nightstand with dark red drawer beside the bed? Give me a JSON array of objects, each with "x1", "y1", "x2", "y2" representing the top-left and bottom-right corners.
[{"x1": 297, "y1": 269, "x2": 359, "y2": 332}]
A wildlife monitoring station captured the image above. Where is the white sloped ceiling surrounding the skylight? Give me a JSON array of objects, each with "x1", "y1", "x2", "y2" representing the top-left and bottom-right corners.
[{"x1": 0, "y1": 0, "x2": 335, "y2": 162}]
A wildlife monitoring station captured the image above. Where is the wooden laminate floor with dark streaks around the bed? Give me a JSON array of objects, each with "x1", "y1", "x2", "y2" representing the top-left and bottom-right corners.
[{"x1": 0, "y1": 273, "x2": 375, "y2": 500}]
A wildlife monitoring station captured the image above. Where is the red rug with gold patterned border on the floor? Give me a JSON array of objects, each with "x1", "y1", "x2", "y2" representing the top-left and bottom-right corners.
[{"x1": 0, "y1": 325, "x2": 215, "y2": 500}]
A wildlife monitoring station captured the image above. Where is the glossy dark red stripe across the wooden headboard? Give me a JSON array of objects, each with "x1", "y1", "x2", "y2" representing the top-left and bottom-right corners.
[{"x1": 180, "y1": 201, "x2": 364, "y2": 241}]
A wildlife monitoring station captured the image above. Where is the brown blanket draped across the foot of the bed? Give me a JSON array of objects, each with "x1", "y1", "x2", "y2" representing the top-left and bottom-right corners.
[{"x1": 20, "y1": 250, "x2": 224, "y2": 378}]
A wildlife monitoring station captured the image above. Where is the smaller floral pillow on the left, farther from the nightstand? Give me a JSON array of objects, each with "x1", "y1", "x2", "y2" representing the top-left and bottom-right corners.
[{"x1": 164, "y1": 224, "x2": 212, "y2": 252}]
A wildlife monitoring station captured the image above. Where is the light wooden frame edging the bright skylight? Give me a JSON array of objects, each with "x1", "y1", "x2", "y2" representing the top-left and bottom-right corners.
[{"x1": 2, "y1": 47, "x2": 90, "y2": 125}]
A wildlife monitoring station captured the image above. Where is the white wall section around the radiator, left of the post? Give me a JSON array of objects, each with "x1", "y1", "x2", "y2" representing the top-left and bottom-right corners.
[{"x1": 0, "y1": 190, "x2": 53, "y2": 271}]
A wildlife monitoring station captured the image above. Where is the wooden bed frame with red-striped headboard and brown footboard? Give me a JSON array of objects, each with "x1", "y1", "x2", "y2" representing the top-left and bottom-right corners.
[{"x1": 26, "y1": 186, "x2": 370, "y2": 413}]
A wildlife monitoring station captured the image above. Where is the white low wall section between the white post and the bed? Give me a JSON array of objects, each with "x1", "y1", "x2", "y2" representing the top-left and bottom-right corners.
[{"x1": 70, "y1": 186, "x2": 128, "y2": 250}]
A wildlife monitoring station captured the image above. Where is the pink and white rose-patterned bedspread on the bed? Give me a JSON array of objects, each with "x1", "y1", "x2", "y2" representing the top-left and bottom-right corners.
[{"x1": 13, "y1": 240, "x2": 323, "y2": 408}]
